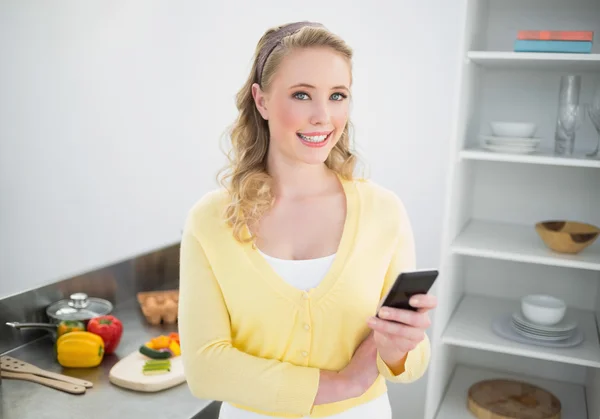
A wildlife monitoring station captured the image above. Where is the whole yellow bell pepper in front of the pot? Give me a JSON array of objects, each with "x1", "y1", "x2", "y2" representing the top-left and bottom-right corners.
[{"x1": 56, "y1": 331, "x2": 104, "y2": 368}]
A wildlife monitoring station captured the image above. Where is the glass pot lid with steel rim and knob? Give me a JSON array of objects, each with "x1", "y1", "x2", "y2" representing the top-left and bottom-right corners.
[{"x1": 46, "y1": 292, "x2": 113, "y2": 320}]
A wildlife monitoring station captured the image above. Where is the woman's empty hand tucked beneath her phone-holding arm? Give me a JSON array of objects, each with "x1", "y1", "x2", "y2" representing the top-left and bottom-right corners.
[{"x1": 339, "y1": 332, "x2": 379, "y2": 397}]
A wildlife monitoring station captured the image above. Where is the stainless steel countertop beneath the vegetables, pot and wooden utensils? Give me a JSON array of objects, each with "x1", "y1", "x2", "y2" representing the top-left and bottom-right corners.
[{"x1": 0, "y1": 299, "x2": 212, "y2": 419}]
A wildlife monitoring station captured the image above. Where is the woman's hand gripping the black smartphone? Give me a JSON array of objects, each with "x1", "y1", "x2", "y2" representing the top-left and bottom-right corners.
[{"x1": 368, "y1": 294, "x2": 437, "y2": 374}]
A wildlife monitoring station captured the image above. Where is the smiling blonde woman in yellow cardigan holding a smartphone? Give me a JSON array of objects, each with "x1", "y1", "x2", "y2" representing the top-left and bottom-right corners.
[{"x1": 179, "y1": 22, "x2": 436, "y2": 419}]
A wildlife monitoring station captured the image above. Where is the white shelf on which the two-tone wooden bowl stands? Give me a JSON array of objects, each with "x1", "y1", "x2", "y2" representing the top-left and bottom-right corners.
[{"x1": 451, "y1": 219, "x2": 600, "y2": 271}]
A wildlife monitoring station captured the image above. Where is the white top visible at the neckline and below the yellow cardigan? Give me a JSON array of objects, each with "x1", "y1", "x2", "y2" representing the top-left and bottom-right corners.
[{"x1": 219, "y1": 250, "x2": 392, "y2": 419}]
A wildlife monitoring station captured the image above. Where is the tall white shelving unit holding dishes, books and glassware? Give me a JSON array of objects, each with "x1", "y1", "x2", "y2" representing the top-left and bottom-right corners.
[{"x1": 425, "y1": 0, "x2": 600, "y2": 419}]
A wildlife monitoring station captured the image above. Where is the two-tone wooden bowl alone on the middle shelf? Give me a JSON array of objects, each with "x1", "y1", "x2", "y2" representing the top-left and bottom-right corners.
[{"x1": 535, "y1": 220, "x2": 600, "y2": 254}]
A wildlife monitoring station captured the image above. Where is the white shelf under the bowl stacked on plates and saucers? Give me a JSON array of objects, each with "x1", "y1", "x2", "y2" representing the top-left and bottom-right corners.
[{"x1": 442, "y1": 295, "x2": 600, "y2": 368}]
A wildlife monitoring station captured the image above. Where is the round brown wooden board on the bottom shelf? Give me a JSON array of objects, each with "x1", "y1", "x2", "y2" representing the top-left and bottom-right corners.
[{"x1": 468, "y1": 380, "x2": 561, "y2": 419}]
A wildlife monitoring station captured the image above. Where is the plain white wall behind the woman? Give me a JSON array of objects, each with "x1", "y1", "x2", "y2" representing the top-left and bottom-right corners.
[{"x1": 0, "y1": 0, "x2": 462, "y2": 418}]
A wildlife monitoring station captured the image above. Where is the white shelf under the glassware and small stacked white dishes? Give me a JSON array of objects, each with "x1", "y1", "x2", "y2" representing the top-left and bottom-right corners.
[{"x1": 459, "y1": 147, "x2": 600, "y2": 169}]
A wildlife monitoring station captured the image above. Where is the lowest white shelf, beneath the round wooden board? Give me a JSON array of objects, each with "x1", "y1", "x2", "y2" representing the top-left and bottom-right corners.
[{"x1": 436, "y1": 365, "x2": 588, "y2": 419}]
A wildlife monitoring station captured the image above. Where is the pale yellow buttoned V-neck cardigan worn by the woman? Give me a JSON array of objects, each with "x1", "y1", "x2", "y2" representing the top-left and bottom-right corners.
[{"x1": 179, "y1": 178, "x2": 430, "y2": 418}]
